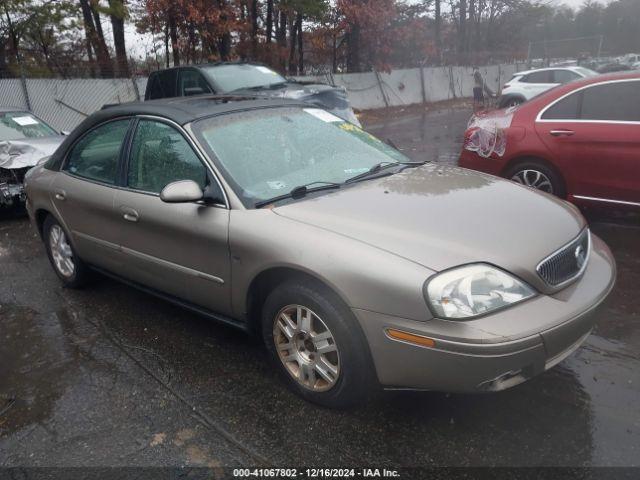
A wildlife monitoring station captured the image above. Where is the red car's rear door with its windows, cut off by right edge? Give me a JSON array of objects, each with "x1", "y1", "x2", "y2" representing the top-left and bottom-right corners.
[{"x1": 536, "y1": 80, "x2": 640, "y2": 203}]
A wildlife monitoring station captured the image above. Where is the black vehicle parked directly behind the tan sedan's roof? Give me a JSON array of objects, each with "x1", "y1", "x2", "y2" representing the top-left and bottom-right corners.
[{"x1": 144, "y1": 62, "x2": 360, "y2": 126}]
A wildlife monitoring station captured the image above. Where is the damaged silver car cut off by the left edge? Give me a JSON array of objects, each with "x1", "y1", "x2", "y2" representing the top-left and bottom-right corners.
[{"x1": 0, "y1": 107, "x2": 64, "y2": 209}]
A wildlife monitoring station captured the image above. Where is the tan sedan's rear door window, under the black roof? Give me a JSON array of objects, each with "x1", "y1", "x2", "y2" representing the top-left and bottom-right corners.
[{"x1": 64, "y1": 119, "x2": 130, "y2": 185}]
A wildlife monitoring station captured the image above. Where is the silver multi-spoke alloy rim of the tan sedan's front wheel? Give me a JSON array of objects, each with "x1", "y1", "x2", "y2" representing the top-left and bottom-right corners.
[{"x1": 273, "y1": 305, "x2": 340, "y2": 392}]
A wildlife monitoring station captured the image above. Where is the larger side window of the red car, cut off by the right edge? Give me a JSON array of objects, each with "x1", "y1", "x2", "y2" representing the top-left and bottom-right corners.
[{"x1": 581, "y1": 82, "x2": 640, "y2": 122}]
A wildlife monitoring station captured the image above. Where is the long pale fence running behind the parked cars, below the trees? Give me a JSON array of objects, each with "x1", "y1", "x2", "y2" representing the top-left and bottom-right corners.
[{"x1": 0, "y1": 64, "x2": 521, "y2": 130}]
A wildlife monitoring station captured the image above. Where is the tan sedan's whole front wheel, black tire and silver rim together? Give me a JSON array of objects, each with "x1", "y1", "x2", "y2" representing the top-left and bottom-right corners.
[{"x1": 262, "y1": 279, "x2": 373, "y2": 408}]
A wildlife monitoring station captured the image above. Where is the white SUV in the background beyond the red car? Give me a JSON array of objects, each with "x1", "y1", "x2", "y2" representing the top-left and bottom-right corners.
[{"x1": 498, "y1": 67, "x2": 598, "y2": 108}]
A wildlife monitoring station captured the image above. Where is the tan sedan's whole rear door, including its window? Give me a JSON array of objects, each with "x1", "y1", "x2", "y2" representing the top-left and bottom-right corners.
[{"x1": 52, "y1": 118, "x2": 131, "y2": 270}]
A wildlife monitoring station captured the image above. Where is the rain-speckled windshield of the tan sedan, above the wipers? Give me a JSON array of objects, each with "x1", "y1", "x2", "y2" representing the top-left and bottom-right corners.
[{"x1": 194, "y1": 107, "x2": 410, "y2": 206}]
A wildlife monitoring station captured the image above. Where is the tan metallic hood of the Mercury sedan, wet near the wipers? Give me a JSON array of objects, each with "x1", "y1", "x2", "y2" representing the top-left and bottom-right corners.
[{"x1": 273, "y1": 164, "x2": 585, "y2": 293}]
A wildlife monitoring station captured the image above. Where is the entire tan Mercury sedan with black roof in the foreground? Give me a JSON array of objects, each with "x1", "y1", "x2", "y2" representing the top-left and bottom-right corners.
[{"x1": 27, "y1": 97, "x2": 615, "y2": 407}]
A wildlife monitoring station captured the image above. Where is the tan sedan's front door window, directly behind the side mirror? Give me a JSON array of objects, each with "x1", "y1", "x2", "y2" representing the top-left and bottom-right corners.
[{"x1": 127, "y1": 120, "x2": 207, "y2": 193}]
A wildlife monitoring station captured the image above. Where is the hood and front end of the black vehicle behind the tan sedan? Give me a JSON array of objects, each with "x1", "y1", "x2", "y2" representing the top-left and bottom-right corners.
[{"x1": 233, "y1": 81, "x2": 360, "y2": 126}]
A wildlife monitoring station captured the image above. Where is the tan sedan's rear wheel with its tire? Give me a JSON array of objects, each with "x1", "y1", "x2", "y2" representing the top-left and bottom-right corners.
[{"x1": 42, "y1": 215, "x2": 90, "y2": 288}]
